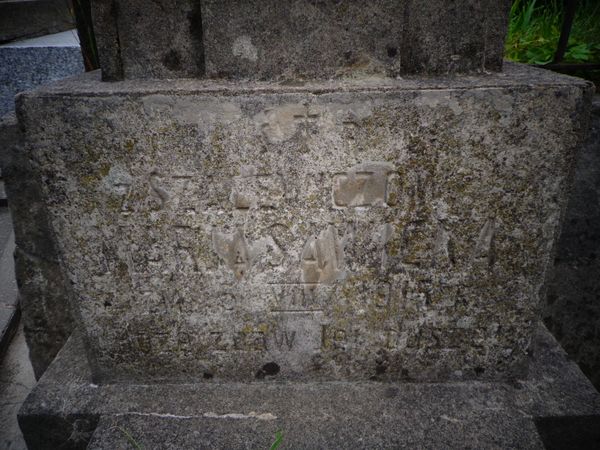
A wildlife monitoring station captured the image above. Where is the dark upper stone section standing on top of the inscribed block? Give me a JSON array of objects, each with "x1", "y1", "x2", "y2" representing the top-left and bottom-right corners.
[{"x1": 93, "y1": 0, "x2": 510, "y2": 80}]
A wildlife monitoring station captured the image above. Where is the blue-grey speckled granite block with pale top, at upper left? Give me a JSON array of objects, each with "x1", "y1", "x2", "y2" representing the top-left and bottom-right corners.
[{"x1": 0, "y1": 30, "x2": 83, "y2": 116}]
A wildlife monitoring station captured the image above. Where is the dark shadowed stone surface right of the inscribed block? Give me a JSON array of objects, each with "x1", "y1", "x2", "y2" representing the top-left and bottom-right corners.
[{"x1": 543, "y1": 97, "x2": 600, "y2": 388}]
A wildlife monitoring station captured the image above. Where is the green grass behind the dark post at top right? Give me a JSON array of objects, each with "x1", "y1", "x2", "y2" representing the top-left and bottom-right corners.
[{"x1": 505, "y1": 0, "x2": 600, "y2": 64}]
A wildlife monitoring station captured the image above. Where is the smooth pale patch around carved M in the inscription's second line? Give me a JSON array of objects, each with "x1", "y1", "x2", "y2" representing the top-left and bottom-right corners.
[{"x1": 302, "y1": 226, "x2": 344, "y2": 283}]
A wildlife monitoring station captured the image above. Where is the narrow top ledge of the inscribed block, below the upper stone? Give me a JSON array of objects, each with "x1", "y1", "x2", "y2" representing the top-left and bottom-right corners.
[{"x1": 17, "y1": 62, "x2": 593, "y2": 102}]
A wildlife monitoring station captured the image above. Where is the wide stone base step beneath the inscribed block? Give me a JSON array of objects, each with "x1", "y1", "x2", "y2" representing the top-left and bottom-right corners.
[{"x1": 19, "y1": 326, "x2": 600, "y2": 450}]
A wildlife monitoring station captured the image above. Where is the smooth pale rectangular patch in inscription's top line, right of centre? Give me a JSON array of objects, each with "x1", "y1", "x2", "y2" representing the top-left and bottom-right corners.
[{"x1": 333, "y1": 162, "x2": 394, "y2": 208}]
